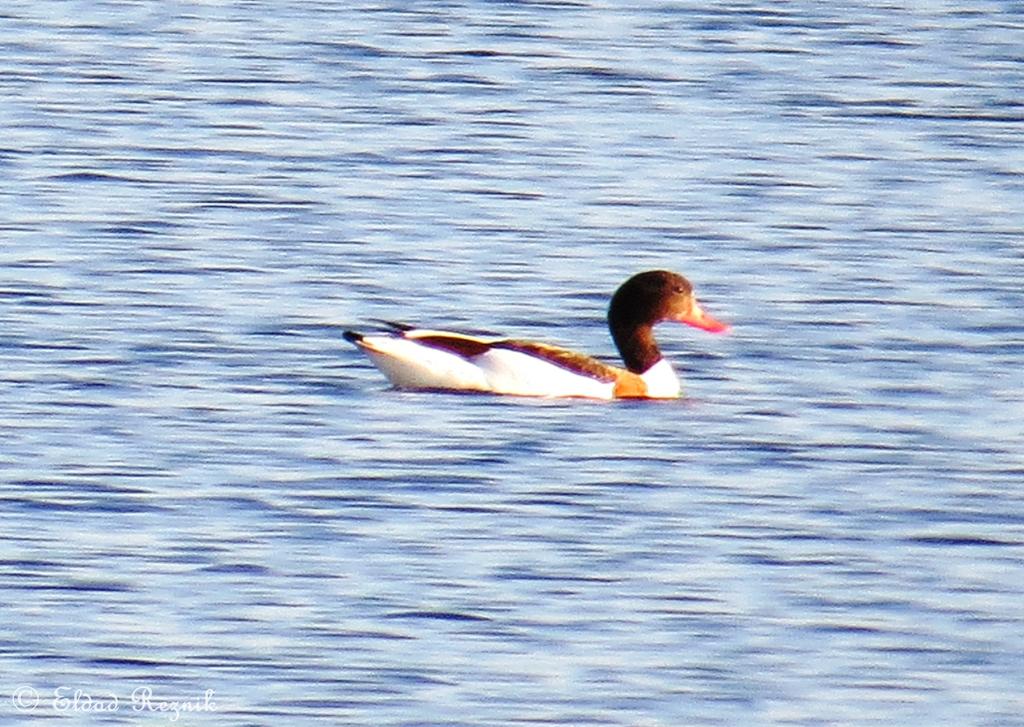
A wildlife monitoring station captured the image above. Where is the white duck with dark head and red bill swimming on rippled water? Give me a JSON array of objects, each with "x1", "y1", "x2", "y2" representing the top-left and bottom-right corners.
[{"x1": 343, "y1": 270, "x2": 729, "y2": 399}]
